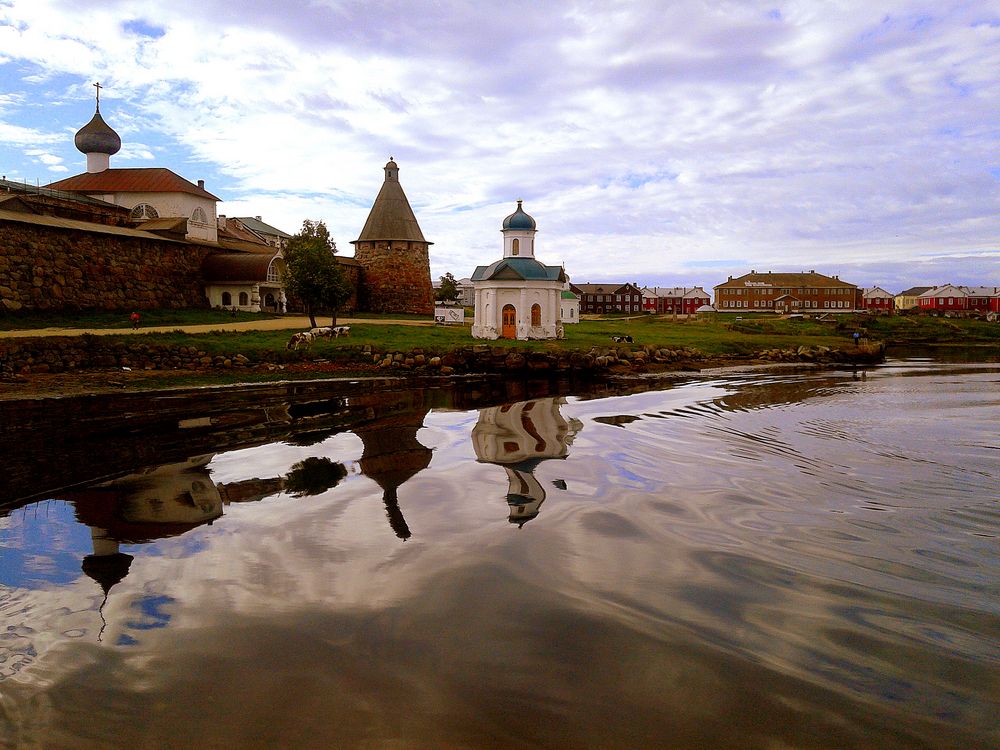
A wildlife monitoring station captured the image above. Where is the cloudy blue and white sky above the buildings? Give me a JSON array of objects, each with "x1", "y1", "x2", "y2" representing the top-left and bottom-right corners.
[{"x1": 0, "y1": 0, "x2": 1000, "y2": 292}]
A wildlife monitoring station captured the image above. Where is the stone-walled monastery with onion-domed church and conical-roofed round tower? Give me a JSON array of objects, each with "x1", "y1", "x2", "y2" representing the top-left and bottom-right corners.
[{"x1": 0, "y1": 89, "x2": 434, "y2": 316}]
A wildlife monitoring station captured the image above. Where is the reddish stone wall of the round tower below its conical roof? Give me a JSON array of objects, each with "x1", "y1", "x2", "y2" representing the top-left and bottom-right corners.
[{"x1": 354, "y1": 240, "x2": 434, "y2": 315}]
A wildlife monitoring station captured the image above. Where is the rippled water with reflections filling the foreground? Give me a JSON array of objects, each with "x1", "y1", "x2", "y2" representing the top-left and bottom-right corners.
[{"x1": 0, "y1": 360, "x2": 1000, "y2": 749}]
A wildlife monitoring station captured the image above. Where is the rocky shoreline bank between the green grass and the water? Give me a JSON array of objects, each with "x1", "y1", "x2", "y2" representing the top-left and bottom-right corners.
[{"x1": 0, "y1": 336, "x2": 884, "y2": 400}]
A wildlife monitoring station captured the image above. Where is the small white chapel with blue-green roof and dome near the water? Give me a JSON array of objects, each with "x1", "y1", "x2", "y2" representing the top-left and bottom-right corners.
[{"x1": 471, "y1": 201, "x2": 567, "y2": 340}]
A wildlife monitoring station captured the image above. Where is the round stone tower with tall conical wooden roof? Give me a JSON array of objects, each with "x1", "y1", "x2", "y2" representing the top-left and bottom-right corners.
[{"x1": 351, "y1": 157, "x2": 434, "y2": 315}]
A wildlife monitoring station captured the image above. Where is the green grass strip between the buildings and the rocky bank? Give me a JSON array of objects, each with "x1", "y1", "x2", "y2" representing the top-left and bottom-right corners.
[{"x1": 0, "y1": 310, "x2": 1000, "y2": 359}]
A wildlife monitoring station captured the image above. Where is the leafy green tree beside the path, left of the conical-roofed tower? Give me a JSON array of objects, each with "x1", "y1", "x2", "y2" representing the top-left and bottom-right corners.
[{"x1": 284, "y1": 219, "x2": 353, "y2": 328}]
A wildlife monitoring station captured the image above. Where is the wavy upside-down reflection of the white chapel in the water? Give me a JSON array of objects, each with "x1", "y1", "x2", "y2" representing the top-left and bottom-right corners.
[{"x1": 472, "y1": 397, "x2": 582, "y2": 528}]
